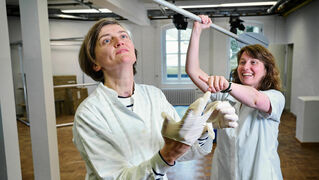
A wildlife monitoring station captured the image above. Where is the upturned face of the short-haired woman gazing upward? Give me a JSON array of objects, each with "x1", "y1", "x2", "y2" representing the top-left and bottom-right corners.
[{"x1": 94, "y1": 24, "x2": 136, "y2": 72}]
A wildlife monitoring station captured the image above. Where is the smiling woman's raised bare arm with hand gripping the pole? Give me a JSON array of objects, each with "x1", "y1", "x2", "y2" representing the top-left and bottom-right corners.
[{"x1": 186, "y1": 15, "x2": 212, "y2": 92}]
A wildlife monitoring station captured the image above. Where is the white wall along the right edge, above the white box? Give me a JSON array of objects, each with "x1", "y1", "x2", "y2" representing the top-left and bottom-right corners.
[{"x1": 286, "y1": 1, "x2": 319, "y2": 114}]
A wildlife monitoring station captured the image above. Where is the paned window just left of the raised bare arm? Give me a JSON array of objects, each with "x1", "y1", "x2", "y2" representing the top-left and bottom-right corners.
[{"x1": 162, "y1": 25, "x2": 192, "y2": 83}]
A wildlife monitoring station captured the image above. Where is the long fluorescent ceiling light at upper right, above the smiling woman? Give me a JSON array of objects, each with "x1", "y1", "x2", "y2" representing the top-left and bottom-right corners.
[{"x1": 178, "y1": 1, "x2": 277, "y2": 9}]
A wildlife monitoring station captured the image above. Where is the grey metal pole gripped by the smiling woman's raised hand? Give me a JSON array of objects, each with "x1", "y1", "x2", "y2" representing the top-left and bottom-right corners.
[{"x1": 153, "y1": 0, "x2": 250, "y2": 45}]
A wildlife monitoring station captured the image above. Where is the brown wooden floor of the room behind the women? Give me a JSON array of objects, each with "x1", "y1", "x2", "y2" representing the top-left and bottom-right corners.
[{"x1": 18, "y1": 112, "x2": 319, "y2": 180}]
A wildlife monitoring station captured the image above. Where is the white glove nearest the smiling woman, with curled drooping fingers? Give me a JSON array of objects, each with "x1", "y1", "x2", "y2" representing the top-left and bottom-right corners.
[{"x1": 204, "y1": 101, "x2": 238, "y2": 129}]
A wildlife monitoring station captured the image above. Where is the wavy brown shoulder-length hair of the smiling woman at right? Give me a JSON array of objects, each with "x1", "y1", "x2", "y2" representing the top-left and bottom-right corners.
[{"x1": 232, "y1": 44, "x2": 281, "y2": 90}]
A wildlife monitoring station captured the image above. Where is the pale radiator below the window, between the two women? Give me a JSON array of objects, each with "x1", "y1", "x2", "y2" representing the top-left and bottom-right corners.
[{"x1": 162, "y1": 89, "x2": 195, "y2": 105}]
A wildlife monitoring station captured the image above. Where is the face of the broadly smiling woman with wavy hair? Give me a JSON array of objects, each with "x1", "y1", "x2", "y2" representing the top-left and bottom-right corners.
[{"x1": 237, "y1": 52, "x2": 267, "y2": 89}]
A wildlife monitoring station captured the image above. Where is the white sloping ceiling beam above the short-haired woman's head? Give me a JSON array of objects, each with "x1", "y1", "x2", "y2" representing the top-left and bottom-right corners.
[{"x1": 93, "y1": 0, "x2": 150, "y2": 26}]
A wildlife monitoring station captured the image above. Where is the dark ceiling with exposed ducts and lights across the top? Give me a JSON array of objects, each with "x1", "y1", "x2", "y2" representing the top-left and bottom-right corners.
[{"x1": 6, "y1": 0, "x2": 311, "y2": 25}]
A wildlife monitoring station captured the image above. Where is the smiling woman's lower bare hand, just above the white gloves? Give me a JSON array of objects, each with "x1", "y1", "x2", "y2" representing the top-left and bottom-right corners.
[{"x1": 199, "y1": 76, "x2": 229, "y2": 93}]
